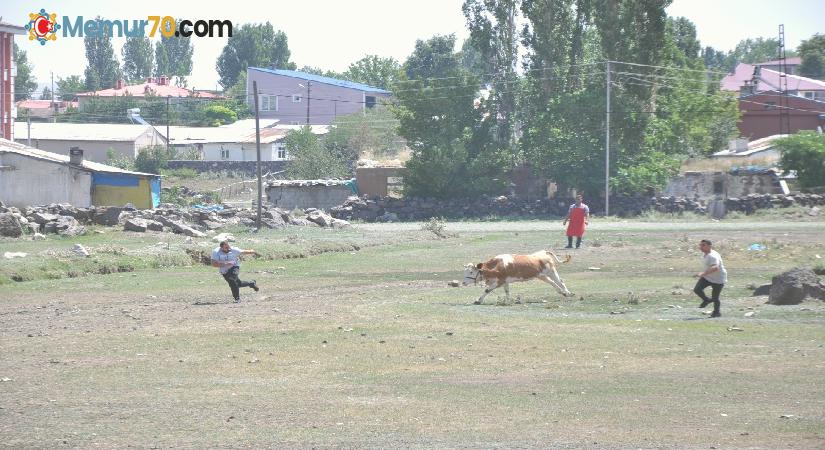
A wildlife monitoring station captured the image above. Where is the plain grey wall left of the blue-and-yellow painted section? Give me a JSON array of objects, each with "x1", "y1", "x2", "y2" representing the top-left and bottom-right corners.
[{"x1": 0, "y1": 153, "x2": 92, "y2": 208}]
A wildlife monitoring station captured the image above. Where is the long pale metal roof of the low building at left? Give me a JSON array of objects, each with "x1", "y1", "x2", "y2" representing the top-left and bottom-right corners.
[{"x1": 14, "y1": 122, "x2": 162, "y2": 142}]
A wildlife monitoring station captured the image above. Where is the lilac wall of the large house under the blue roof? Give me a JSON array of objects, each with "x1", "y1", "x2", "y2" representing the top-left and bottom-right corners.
[{"x1": 247, "y1": 70, "x2": 389, "y2": 125}]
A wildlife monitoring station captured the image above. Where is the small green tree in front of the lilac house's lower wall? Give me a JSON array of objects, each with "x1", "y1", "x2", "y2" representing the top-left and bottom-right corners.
[{"x1": 284, "y1": 126, "x2": 352, "y2": 180}]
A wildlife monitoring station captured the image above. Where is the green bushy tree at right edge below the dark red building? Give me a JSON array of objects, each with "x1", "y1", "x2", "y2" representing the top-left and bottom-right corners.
[{"x1": 776, "y1": 131, "x2": 825, "y2": 189}]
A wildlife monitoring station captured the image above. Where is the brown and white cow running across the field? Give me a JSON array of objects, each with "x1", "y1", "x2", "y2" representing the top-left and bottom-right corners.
[{"x1": 463, "y1": 250, "x2": 573, "y2": 305}]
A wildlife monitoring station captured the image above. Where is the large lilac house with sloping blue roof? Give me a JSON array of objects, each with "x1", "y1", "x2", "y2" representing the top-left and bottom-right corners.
[{"x1": 246, "y1": 67, "x2": 392, "y2": 125}]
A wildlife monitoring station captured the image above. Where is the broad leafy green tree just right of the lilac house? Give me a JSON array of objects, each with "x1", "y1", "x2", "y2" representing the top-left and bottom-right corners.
[{"x1": 393, "y1": 35, "x2": 509, "y2": 198}]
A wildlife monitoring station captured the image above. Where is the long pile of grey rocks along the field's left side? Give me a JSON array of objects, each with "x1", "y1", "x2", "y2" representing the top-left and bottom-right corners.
[{"x1": 0, "y1": 204, "x2": 349, "y2": 237}]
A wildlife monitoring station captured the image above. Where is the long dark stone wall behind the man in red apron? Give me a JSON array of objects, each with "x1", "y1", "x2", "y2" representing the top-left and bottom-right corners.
[{"x1": 330, "y1": 194, "x2": 825, "y2": 222}]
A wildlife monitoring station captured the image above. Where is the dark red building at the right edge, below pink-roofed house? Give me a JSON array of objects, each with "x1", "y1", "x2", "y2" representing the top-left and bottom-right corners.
[{"x1": 739, "y1": 91, "x2": 825, "y2": 140}]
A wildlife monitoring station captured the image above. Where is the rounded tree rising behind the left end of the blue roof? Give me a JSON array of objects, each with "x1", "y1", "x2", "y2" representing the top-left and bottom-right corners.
[{"x1": 216, "y1": 22, "x2": 296, "y2": 88}]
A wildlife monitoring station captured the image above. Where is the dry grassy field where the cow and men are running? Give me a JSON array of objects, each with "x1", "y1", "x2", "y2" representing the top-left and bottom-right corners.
[{"x1": 0, "y1": 216, "x2": 825, "y2": 449}]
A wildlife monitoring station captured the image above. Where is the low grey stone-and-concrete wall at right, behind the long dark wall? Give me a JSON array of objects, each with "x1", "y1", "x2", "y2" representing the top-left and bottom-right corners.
[{"x1": 663, "y1": 172, "x2": 782, "y2": 200}]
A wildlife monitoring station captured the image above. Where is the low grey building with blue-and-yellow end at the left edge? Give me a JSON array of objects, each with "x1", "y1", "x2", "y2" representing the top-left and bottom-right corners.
[{"x1": 0, "y1": 139, "x2": 160, "y2": 209}]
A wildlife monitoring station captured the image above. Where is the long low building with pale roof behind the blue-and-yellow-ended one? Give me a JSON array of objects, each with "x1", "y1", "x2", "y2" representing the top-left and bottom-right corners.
[{"x1": 14, "y1": 122, "x2": 166, "y2": 163}]
